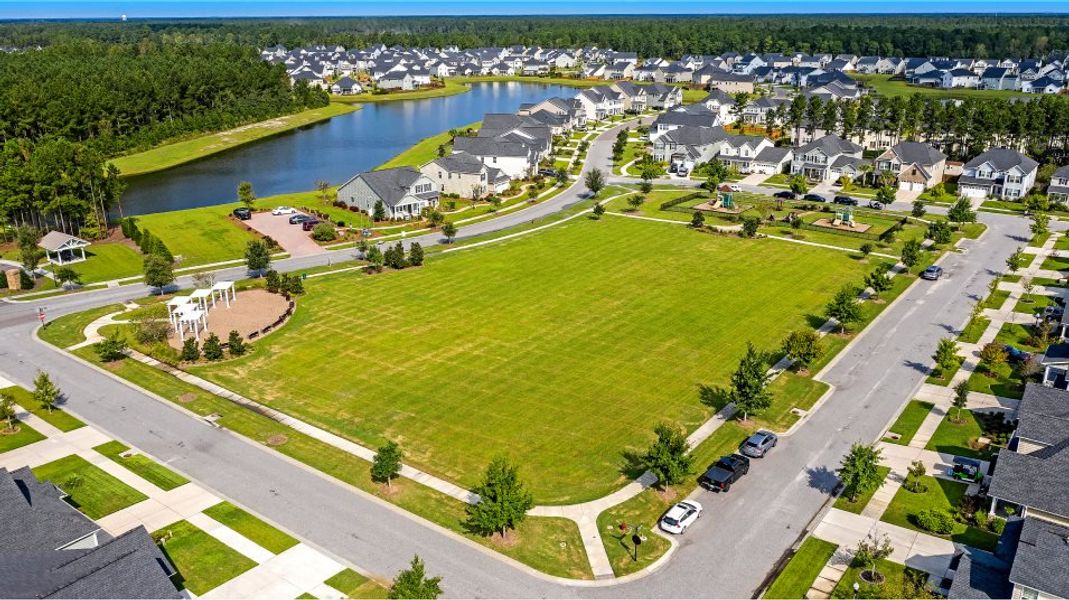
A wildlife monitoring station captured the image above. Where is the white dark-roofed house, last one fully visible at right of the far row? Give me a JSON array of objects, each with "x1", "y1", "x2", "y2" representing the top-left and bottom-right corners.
[{"x1": 958, "y1": 148, "x2": 1039, "y2": 200}]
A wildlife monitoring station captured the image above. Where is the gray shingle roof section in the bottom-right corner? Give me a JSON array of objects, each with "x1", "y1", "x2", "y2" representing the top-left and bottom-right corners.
[{"x1": 1009, "y1": 513, "x2": 1069, "y2": 598}]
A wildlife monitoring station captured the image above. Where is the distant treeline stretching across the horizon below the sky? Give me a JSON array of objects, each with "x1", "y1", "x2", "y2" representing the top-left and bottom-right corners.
[{"x1": 0, "y1": 15, "x2": 1069, "y2": 58}]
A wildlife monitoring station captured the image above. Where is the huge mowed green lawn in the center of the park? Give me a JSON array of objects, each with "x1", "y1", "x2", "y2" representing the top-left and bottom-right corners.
[{"x1": 195, "y1": 217, "x2": 867, "y2": 503}]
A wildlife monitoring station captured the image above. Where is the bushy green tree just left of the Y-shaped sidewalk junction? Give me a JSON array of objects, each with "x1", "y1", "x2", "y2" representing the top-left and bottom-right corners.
[{"x1": 467, "y1": 457, "x2": 535, "y2": 537}]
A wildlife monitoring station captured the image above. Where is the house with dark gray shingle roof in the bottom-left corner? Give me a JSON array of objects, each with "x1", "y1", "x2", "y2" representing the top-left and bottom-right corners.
[{"x1": 0, "y1": 466, "x2": 185, "y2": 598}]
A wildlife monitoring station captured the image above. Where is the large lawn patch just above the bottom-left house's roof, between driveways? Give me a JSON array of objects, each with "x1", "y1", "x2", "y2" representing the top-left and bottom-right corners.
[{"x1": 33, "y1": 455, "x2": 148, "y2": 519}]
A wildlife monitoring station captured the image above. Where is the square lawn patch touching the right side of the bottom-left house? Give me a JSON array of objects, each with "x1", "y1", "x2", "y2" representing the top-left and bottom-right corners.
[{"x1": 152, "y1": 521, "x2": 257, "y2": 596}]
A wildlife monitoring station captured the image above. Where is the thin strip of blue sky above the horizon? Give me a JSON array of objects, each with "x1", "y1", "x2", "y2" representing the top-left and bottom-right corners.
[{"x1": 6, "y1": 0, "x2": 1069, "y2": 19}]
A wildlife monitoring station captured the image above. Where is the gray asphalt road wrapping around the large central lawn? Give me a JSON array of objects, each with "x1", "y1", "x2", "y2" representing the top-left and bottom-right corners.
[{"x1": 0, "y1": 126, "x2": 1027, "y2": 598}]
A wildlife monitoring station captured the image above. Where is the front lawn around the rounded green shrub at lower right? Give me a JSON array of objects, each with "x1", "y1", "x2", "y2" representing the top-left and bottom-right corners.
[{"x1": 880, "y1": 475, "x2": 997, "y2": 551}]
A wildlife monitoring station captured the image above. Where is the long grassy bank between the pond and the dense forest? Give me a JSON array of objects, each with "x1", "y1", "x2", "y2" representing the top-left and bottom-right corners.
[{"x1": 111, "y1": 103, "x2": 357, "y2": 176}]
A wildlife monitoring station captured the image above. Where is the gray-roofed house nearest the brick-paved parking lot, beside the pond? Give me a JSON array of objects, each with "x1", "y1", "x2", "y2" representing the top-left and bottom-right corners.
[{"x1": 338, "y1": 164, "x2": 438, "y2": 219}]
